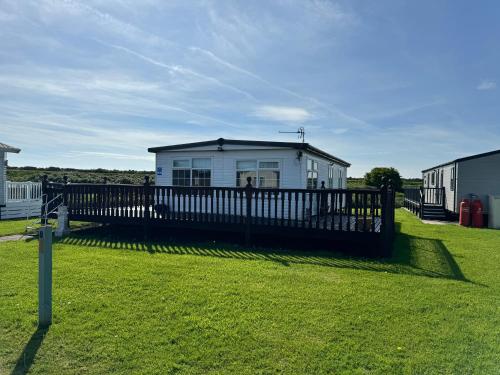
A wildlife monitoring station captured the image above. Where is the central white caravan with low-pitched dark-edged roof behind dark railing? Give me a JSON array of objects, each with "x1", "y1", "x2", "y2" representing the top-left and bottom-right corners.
[{"x1": 148, "y1": 138, "x2": 350, "y2": 220}]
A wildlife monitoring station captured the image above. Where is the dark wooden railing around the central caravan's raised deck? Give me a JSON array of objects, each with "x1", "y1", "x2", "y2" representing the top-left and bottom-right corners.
[{"x1": 43, "y1": 178, "x2": 394, "y2": 254}]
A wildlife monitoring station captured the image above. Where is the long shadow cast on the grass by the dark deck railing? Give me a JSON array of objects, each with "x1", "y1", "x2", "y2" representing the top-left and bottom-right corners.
[{"x1": 54, "y1": 227, "x2": 469, "y2": 282}]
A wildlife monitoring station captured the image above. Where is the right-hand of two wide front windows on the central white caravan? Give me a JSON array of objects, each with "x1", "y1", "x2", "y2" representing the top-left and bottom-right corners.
[{"x1": 236, "y1": 160, "x2": 280, "y2": 189}]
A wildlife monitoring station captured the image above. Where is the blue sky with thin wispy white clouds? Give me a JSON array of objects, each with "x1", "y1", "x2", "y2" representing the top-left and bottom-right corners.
[{"x1": 0, "y1": 0, "x2": 500, "y2": 177}]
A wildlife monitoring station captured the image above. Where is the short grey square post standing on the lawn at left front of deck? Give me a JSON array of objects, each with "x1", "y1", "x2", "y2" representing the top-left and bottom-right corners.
[{"x1": 38, "y1": 225, "x2": 52, "y2": 327}]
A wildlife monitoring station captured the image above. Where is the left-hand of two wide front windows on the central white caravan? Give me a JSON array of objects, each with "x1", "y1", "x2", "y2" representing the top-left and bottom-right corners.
[{"x1": 172, "y1": 158, "x2": 212, "y2": 186}]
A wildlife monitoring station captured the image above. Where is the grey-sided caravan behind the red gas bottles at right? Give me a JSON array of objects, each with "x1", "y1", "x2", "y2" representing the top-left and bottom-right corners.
[{"x1": 422, "y1": 150, "x2": 500, "y2": 222}]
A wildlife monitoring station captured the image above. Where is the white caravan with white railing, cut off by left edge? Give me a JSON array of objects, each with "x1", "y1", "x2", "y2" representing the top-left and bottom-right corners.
[{"x1": 0, "y1": 143, "x2": 42, "y2": 220}]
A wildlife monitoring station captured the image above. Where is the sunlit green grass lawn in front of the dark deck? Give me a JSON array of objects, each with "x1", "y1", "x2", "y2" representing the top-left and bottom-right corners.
[{"x1": 0, "y1": 210, "x2": 500, "y2": 374}]
